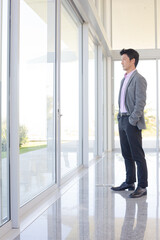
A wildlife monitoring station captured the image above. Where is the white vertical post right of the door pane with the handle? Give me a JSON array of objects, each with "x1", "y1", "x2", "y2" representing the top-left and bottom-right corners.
[{"x1": 82, "y1": 24, "x2": 89, "y2": 167}]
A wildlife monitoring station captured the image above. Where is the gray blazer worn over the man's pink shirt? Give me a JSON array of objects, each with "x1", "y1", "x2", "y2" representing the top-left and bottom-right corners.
[{"x1": 118, "y1": 70, "x2": 147, "y2": 129}]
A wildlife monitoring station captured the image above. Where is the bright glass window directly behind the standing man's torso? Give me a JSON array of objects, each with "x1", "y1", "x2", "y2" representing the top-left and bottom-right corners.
[{"x1": 114, "y1": 60, "x2": 156, "y2": 149}]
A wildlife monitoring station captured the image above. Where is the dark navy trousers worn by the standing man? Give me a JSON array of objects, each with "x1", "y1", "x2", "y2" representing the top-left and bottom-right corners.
[{"x1": 118, "y1": 116, "x2": 148, "y2": 188}]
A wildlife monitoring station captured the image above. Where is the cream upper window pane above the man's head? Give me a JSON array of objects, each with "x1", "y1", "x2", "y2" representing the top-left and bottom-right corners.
[{"x1": 112, "y1": 0, "x2": 155, "y2": 49}]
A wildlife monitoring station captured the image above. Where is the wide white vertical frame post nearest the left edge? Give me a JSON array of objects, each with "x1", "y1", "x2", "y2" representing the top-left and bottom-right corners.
[{"x1": 10, "y1": 0, "x2": 20, "y2": 228}]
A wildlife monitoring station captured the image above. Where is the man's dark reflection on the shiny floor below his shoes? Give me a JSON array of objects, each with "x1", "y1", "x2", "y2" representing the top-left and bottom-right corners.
[{"x1": 120, "y1": 197, "x2": 148, "y2": 240}]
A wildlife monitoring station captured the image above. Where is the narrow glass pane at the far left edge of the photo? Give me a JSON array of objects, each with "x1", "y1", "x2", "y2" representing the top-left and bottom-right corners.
[{"x1": 0, "y1": 1, "x2": 10, "y2": 226}]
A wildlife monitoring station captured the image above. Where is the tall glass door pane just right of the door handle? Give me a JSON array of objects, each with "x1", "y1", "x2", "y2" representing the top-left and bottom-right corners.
[{"x1": 60, "y1": 2, "x2": 82, "y2": 177}]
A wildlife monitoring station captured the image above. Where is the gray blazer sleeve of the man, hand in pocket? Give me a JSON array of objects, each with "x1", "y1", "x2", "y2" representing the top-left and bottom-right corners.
[{"x1": 129, "y1": 75, "x2": 147, "y2": 126}]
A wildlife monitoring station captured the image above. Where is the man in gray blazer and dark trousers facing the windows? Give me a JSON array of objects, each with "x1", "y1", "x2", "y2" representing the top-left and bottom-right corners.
[{"x1": 111, "y1": 49, "x2": 148, "y2": 198}]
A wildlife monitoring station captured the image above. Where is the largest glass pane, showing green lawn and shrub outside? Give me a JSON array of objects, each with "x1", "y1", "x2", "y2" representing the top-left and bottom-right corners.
[{"x1": 19, "y1": 0, "x2": 55, "y2": 205}]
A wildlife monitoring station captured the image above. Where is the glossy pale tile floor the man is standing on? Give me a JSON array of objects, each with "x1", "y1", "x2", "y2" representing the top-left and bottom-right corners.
[{"x1": 2, "y1": 152, "x2": 160, "y2": 240}]
